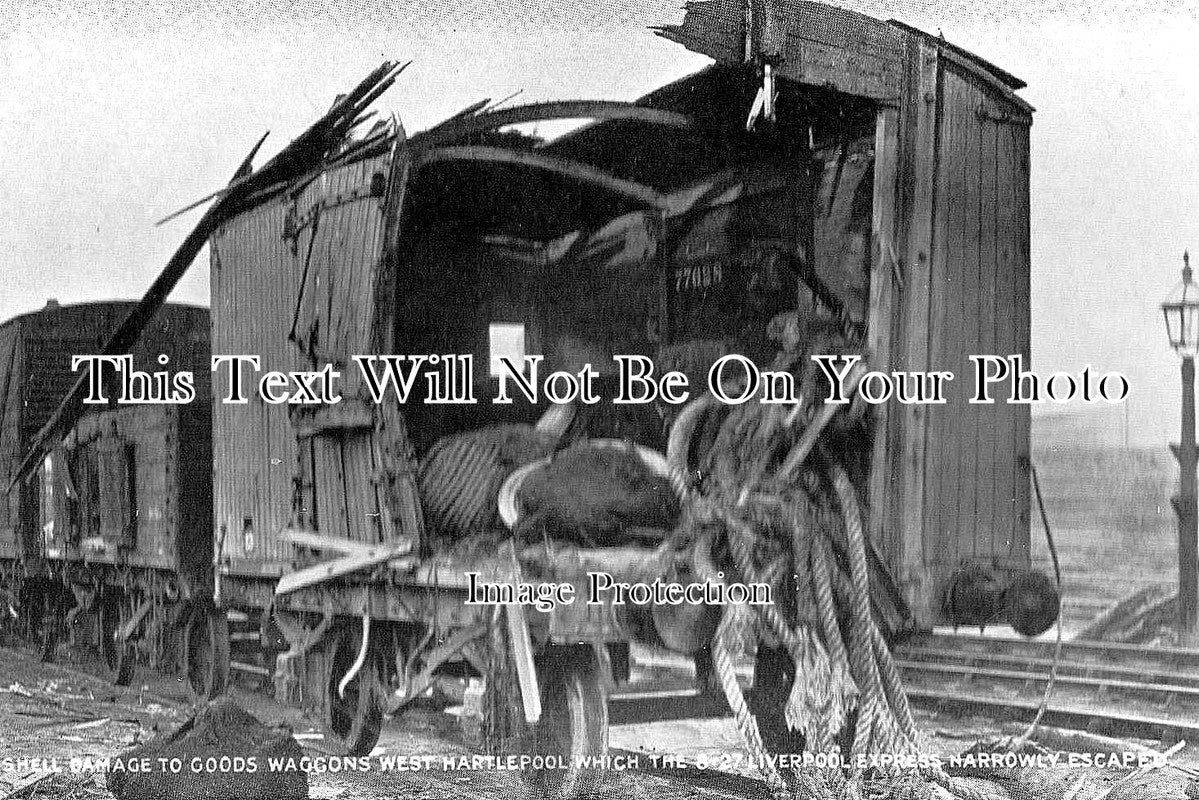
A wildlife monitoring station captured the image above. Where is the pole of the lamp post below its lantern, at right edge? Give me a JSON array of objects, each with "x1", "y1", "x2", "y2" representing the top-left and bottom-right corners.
[{"x1": 1174, "y1": 355, "x2": 1199, "y2": 645}]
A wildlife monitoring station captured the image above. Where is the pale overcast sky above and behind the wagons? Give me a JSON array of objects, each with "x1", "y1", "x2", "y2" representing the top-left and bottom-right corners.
[{"x1": 0, "y1": 0, "x2": 1199, "y2": 445}]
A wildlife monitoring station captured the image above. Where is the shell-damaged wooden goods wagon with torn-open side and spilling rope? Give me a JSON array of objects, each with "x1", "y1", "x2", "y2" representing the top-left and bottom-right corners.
[{"x1": 7, "y1": 2, "x2": 1058, "y2": 794}]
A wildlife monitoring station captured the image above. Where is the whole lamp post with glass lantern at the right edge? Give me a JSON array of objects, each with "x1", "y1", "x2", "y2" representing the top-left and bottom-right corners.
[{"x1": 1162, "y1": 253, "x2": 1199, "y2": 644}]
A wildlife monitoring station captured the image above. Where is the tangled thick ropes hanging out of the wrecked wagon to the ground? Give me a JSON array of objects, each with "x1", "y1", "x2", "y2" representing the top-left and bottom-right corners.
[{"x1": 668, "y1": 340, "x2": 1008, "y2": 800}]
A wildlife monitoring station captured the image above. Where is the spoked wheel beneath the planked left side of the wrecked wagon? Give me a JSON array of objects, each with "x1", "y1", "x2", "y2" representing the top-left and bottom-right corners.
[{"x1": 324, "y1": 626, "x2": 384, "y2": 756}]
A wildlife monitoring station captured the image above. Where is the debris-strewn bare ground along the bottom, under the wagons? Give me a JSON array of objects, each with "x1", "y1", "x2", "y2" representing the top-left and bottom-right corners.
[{"x1": 0, "y1": 648, "x2": 1194, "y2": 800}]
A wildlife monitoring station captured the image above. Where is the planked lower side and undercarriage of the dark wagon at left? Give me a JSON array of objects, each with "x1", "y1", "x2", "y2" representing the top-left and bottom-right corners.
[{"x1": 36, "y1": 398, "x2": 215, "y2": 696}]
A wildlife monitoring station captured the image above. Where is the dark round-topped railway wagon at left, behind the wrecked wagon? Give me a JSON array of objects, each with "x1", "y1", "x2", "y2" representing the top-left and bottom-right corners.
[{"x1": 0, "y1": 302, "x2": 211, "y2": 669}]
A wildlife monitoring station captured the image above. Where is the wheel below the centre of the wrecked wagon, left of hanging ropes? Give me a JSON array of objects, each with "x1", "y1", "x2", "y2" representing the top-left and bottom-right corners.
[{"x1": 526, "y1": 646, "x2": 608, "y2": 799}]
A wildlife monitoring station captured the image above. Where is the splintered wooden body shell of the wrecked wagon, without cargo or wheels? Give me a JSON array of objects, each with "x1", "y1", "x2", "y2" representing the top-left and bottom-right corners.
[{"x1": 211, "y1": 1, "x2": 1032, "y2": 647}]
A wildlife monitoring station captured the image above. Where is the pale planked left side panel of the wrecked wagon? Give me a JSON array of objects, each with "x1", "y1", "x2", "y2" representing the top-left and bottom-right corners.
[{"x1": 212, "y1": 156, "x2": 387, "y2": 576}]
